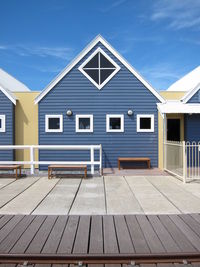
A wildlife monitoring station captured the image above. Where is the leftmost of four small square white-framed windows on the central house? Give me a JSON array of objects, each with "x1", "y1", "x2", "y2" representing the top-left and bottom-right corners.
[{"x1": 45, "y1": 115, "x2": 63, "y2": 133}]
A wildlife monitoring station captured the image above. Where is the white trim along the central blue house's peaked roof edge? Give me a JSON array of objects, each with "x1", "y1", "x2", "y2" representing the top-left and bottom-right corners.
[{"x1": 35, "y1": 35, "x2": 165, "y2": 104}]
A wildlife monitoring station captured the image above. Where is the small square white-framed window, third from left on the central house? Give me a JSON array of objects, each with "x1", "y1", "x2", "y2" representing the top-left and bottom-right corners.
[{"x1": 106, "y1": 114, "x2": 124, "y2": 133}]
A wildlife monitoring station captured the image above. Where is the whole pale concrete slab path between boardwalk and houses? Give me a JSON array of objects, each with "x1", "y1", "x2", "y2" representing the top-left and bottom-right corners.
[{"x1": 0, "y1": 175, "x2": 200, "y2": 215}]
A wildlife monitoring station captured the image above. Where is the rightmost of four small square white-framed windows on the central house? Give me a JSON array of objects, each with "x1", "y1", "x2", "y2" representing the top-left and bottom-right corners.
[{"x1": 137, "y1": 114, "x2": 154, "y2": 133}]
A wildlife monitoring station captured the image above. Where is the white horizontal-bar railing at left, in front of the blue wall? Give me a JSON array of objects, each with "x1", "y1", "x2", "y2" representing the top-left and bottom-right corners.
[{"x1": 0, "y1": 145, "x2": 102, "y2": 177}]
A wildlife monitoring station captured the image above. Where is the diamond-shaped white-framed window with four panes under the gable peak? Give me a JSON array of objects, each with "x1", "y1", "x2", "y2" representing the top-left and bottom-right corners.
[{"x1": 79, "y1": 48, "x2": 120, "y2": 89}]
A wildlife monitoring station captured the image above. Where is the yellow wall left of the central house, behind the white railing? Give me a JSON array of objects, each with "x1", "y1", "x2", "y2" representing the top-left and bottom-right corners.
[{"x1": 15, "y1": 92, "x2": 39, "y2": 167}]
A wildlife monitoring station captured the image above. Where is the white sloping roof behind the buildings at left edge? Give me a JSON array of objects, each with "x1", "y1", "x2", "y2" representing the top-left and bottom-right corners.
[{"x1": 0, "y1": 69, "x2": 30, "y2": 92}]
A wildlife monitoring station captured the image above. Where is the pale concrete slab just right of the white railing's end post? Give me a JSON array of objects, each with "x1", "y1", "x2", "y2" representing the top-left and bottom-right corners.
[{"x1": 104, "y1": 176, "x2": 143, "y2": 214}]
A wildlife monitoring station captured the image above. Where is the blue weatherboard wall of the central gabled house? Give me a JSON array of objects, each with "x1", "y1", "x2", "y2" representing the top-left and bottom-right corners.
[{"x1": 39, "y1": 43, "x2": 159, "y2": 172}]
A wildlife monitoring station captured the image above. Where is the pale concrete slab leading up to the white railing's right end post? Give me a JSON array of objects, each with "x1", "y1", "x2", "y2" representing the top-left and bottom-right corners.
[{"x1": 70, "y1": 178, "x2": 106, "y2": 214}]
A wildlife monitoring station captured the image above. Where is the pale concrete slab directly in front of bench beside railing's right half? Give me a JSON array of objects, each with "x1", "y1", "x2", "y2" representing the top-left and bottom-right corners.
[{"x1": 33, "y1": 179, "x2": 81, "y2": 215}]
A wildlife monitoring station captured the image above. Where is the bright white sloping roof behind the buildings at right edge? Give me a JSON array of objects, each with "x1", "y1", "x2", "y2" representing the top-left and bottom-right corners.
[{"x1": 167, "y1": 66, "x2": 200, "y2": 92}]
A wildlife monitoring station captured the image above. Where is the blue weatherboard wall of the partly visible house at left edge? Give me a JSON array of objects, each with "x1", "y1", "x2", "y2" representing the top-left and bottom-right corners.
[{"x1": 0, "y1": 91, "x2": 14, "y2": 161}]
